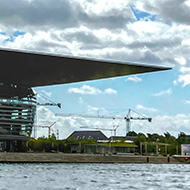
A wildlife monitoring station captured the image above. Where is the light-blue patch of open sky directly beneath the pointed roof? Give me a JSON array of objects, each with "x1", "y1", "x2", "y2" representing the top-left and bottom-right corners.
[{"x1": 35, "y1": 69, "x2": 180, "y2": 116}]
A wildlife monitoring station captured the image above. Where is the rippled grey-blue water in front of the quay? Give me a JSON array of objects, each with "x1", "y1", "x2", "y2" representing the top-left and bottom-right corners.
[{"x1": 0, "y1": 164, "x2": 190, "y2": 190}]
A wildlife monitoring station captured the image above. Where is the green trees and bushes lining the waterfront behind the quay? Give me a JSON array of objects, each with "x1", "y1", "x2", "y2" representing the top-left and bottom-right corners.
[{"x1": 23, "y1": 131, "x2": 190, "y2": 155}]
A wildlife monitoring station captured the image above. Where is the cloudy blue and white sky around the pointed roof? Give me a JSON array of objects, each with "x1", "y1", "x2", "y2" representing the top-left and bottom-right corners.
[{"x1": 0, "y1": 0, "x2": 190, "y2": 139}]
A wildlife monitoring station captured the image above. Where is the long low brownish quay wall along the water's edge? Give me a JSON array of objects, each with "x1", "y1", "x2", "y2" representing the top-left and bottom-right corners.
[{"x1": 0, "y1": 153, "x2": 186, "y2": 164}]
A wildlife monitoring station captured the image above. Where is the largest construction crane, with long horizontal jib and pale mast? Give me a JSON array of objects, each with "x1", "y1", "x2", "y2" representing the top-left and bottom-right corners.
[{"x1": 56, "y1": 109, "x2": 152, "y2": 135}]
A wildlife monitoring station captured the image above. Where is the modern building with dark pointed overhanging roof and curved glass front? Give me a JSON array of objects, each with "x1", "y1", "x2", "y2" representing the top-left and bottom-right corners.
[{"x1": 0, "y1": 49, "x2": 170, "y2": 151}]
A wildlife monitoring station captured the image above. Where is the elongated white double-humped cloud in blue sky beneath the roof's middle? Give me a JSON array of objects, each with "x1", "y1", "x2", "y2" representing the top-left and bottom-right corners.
[{"x1": 68, "y1": 85, "x2": 117, "y2": 95}]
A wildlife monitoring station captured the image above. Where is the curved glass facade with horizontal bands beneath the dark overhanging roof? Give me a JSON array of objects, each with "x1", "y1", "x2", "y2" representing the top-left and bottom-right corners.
[{"x1": 0, "y1": 82, "x2": 36, "y2": 152}]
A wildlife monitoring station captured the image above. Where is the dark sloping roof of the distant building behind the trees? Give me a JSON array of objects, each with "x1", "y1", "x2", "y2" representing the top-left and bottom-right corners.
[{"x1": 68, "y1": 131, "x2": 109, "y2": 142}]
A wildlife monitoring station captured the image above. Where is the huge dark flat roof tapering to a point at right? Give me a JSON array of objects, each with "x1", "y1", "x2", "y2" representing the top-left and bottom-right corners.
[{"x1": 0, "y1": 49, "x2": 169, "y2": 87}]
